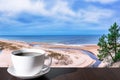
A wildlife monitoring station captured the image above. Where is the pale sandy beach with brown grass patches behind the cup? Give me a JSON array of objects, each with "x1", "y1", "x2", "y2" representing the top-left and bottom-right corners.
[{"x1": 0, "y1": 40, "x2": 103, "y2": 68}]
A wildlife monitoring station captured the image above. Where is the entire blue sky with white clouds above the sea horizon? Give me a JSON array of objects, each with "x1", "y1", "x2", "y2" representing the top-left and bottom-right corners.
[{"x1": 0, "y1": 0, "x2": 120, "y2": 35}]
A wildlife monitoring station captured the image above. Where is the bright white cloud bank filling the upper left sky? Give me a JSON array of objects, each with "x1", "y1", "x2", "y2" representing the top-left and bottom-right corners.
[{"x1": 0, "y1": 0, "x2": 74, "y2": 16}]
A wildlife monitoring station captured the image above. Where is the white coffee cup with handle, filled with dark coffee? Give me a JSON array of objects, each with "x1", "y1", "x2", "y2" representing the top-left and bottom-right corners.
[{"x1": 11, "y1": 49, "x2": 52, "y2": 76}]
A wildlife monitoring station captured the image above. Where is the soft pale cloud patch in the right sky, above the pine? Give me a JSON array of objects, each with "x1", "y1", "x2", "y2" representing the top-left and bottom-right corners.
[{"x1": 79, "y1": 6, "x2": 114, "y2": 22}]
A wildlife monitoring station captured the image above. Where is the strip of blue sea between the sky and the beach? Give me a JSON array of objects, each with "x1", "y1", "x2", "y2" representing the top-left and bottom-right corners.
[{"x1": 0, "y1": 35, "x2": 100, "y2": 45}]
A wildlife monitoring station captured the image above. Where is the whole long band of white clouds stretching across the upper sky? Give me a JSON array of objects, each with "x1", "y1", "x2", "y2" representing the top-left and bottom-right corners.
[{"x1": 0, "y1": 0, "x2": 115, "y2": 22}]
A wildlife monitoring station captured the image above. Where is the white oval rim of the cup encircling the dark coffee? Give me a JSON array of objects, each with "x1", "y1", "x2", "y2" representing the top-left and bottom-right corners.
[{"x1": 11, "y1": 49, "x2": 45, "y2": 57}]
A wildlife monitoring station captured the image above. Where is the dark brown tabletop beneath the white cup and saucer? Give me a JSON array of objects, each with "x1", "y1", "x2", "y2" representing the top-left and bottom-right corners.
[{"x1": 0, "y1": 68, "x2": 120, "y2": 80}]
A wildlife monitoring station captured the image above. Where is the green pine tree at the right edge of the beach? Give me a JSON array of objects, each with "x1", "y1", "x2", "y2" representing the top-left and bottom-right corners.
[{"x1": 98, "y1": 23, "x2": 120, "y2": 62}]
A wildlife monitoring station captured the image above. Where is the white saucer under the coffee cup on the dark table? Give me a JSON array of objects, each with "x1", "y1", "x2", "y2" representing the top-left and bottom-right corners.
[{"x1": 7, "y1": 65, "x2": 50, "y2": 79}]
